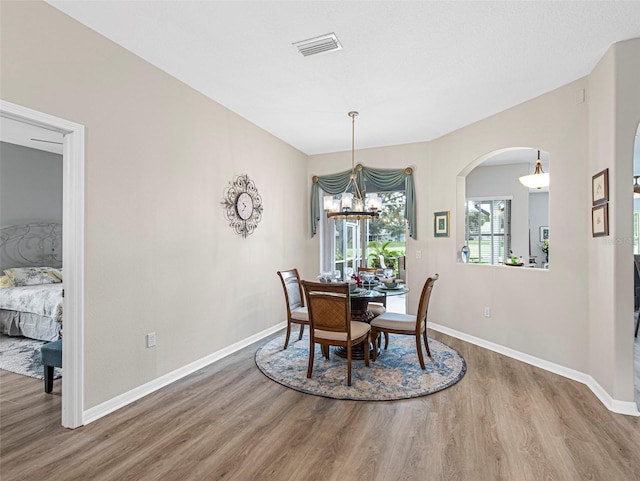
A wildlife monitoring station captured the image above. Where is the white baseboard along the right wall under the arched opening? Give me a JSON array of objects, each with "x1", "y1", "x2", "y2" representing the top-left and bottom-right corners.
[{"x1": 428, "y1": 322, "x2": 640, "y2": 416}]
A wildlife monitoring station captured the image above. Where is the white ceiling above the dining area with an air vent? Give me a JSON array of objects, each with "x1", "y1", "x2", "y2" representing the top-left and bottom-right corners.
[{"x1": 49, "y1": 0, "x2": 640, "y2": 154}]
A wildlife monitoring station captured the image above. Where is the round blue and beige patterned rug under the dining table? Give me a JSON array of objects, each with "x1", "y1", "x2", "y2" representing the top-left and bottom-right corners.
[{"x1": 255, "y1": 332, "x2": 466, "y2": 401}]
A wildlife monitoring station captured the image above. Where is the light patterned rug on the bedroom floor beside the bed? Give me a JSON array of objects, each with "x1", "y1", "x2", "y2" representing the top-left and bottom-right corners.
[{"x1": 0, "y1": 335, "x2": 62, "y2": 379}]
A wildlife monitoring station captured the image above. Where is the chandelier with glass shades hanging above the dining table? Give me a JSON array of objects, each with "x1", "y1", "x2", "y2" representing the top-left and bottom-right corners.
[{"x1": 323, "y1": 111, "x2": 382, "y2": 220}]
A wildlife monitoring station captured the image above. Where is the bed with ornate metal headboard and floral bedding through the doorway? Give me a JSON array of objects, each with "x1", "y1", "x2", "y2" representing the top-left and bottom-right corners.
[{"x1": 0, "y1": 222, "x2": 63, "y2": 341}]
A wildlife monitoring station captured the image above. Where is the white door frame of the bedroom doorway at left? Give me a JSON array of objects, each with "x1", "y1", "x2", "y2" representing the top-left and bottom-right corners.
[{"x1": 0, "y1": 100, "x2": 85, "y2": 429}]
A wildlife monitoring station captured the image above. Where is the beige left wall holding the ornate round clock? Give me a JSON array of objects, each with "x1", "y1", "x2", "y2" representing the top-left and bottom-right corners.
[{"x1": 0, "y1": 2, "x2": 308, "y2": 409}]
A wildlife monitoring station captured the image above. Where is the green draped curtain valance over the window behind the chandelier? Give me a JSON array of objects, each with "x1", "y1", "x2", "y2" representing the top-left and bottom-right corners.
[{"x1": 311, "y1": 164, "x2": 416, "y2": 239}]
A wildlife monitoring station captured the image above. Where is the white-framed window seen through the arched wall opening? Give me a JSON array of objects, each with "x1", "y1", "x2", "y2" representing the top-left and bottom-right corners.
[{"x1": 465, "y1": 199, "x2": 511, "y2": 264}]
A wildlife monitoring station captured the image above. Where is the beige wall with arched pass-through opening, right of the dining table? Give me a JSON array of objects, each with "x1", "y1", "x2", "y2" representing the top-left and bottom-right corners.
[{"x1": 309, "y1": 79, "x2": 589, "y2": 371}]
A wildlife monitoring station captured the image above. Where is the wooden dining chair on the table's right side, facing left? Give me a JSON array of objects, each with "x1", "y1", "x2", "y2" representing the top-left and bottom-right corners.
[{"x1": 371, "y1": 274, "x2": 440, "y2": 369}]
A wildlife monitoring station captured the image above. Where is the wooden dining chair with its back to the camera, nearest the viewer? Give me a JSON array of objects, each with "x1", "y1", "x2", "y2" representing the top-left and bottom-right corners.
[{"x1": 302, "y1": 281, "x2": 371, "y2": 386}]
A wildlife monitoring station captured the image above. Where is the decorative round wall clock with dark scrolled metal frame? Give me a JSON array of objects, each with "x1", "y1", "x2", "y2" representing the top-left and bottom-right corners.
[{"x1": 221, "y1": 174, "x2": 263, "y2": 237}]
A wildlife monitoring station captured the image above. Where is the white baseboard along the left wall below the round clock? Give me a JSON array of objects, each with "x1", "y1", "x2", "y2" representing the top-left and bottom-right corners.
[{"x1": 82, "y1": 322, "x2": 287, "y2": 425}]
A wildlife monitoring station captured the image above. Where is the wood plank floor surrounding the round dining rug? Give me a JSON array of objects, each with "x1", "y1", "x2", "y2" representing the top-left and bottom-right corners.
[{"x1": 0, "y1": 332, "x2": 640, "y2": 481}]
